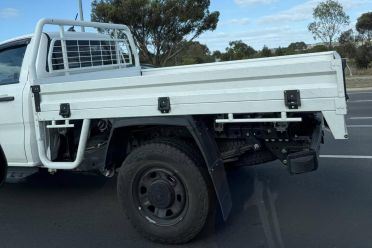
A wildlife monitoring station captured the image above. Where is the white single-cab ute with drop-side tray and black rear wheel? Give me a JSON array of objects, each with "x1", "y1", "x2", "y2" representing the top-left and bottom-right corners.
[{"x1": 0, "y1": 19, "x2": 348, "y2": 243}]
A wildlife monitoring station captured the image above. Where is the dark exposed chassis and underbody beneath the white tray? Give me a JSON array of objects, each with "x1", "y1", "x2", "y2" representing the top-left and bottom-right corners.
[{"x1": 53, "y1": 113, "x2": 323, "y2": 174}]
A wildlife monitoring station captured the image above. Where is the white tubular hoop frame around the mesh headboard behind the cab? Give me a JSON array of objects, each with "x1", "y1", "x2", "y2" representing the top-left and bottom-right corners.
[{"x1": 29, "y1": 19, "x2": 140, "y2": 82}]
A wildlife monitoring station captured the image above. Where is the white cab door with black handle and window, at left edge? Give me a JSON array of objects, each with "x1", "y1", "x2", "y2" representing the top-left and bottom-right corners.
[{"x1": 0, "y1": 39, "x2": 30, "y2": 166}]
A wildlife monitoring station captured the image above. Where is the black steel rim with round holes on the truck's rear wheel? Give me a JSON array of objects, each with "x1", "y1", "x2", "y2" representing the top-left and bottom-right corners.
[{"x1": 133, "y1": 166, "x2": 188, "y2": 226}]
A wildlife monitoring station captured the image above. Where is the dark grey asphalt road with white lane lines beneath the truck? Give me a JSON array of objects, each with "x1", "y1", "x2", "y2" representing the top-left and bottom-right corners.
[{"x1": 0, "y1": 92, "x2": 372, "y2": 248}]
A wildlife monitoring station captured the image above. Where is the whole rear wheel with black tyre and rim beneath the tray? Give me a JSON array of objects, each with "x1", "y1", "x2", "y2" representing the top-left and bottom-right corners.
[{"x1": 118, "y1": 141, "x2": 211, "y2": 244}]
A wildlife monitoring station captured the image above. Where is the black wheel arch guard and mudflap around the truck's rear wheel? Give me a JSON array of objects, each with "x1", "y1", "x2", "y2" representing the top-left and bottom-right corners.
[{"x1": 108, "y1": 116, "x2": 232, "y2": 219}]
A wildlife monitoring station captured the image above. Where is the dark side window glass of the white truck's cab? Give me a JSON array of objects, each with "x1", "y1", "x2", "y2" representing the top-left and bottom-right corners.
[{"x1": 0, "y1": 45, "x2": 27, "y2": 85}]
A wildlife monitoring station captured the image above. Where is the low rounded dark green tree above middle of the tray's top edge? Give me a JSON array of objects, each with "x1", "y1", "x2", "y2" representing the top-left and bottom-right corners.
[{"x1": 222, "y1": 40, "x2": 257, "y2": 61}]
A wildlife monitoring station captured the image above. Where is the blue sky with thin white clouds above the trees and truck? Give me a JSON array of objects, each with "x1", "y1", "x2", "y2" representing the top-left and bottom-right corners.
[{"x1": 0, "y1": 0, "x2": 372, "y2": 51}]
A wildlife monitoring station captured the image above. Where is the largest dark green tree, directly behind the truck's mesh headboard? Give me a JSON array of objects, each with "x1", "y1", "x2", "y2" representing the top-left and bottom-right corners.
[{"x1": 92, "y1": 0, "x2": 219, "y2": 66}]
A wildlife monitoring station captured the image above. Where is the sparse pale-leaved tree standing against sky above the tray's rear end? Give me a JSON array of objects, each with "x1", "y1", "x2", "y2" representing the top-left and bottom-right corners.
[{"x1": 308, "y1": 0, "x2": 350, "y2": 48}]
